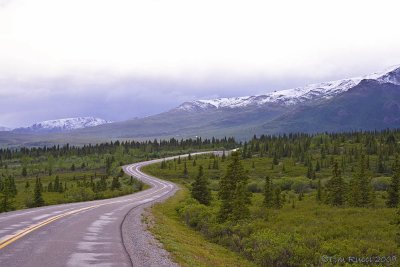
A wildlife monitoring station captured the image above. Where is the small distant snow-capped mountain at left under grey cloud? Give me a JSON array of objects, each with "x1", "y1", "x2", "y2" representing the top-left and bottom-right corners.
[{"x1": 13, "y1": 117, "x2": 110, "y2": 132}]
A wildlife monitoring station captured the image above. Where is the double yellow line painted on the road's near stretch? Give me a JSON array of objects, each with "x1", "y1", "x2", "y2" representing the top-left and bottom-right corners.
[{"x1": 0, "y1": 204, "x2": 104, "y2": 249}]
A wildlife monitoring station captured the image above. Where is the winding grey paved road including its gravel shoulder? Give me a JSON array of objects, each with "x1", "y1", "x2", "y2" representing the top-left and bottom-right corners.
[{"x1": 0, "y1": 152, "x2": 218, "y2": 267}]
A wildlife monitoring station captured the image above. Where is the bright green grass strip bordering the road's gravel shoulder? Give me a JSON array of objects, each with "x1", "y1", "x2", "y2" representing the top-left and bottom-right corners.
[{"x1": 150, "y1": 188, "x2": 255, "y2": 267}]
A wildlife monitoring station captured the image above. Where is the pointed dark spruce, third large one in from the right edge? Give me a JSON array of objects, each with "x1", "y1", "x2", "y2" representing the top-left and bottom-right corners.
[{"x1": 326, "y1": 162, "x2": 345, "y2": 206}]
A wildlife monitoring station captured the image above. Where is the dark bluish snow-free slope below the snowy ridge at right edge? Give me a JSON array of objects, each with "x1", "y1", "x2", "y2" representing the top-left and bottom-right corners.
[{"x1": 259, "y1": 80, "x2": 400, "y2": 133}]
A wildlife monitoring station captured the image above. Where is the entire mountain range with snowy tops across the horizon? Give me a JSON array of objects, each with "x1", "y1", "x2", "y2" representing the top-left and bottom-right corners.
[{"x1": 0, "y1": 66, "x2": 400, "y2": 146}]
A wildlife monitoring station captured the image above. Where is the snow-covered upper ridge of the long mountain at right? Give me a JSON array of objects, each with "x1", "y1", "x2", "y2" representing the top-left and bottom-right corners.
[{"x1": 176, "y1": 65, "x2": 400, "y2": 111}]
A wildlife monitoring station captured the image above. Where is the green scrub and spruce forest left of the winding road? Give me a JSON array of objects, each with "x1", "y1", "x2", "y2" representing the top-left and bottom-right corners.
[{"x1": 0, "y1": 138, "x2": 237, "y2": 212}]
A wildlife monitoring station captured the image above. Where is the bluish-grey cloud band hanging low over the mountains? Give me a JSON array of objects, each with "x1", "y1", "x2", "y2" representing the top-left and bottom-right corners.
[{"x1": 0, "y1": 62, "x2": 396, "y2": 127}]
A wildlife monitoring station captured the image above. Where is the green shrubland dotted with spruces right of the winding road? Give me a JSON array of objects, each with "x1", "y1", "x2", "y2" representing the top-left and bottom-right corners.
[{"x1": 144, "y1": 130, "x2": 400, "y2": 266}]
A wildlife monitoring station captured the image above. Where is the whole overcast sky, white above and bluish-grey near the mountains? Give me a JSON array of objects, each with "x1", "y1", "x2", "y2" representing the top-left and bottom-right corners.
[{"x1": 0, "y1": 0, "x2": 400, "y2": 127}]
